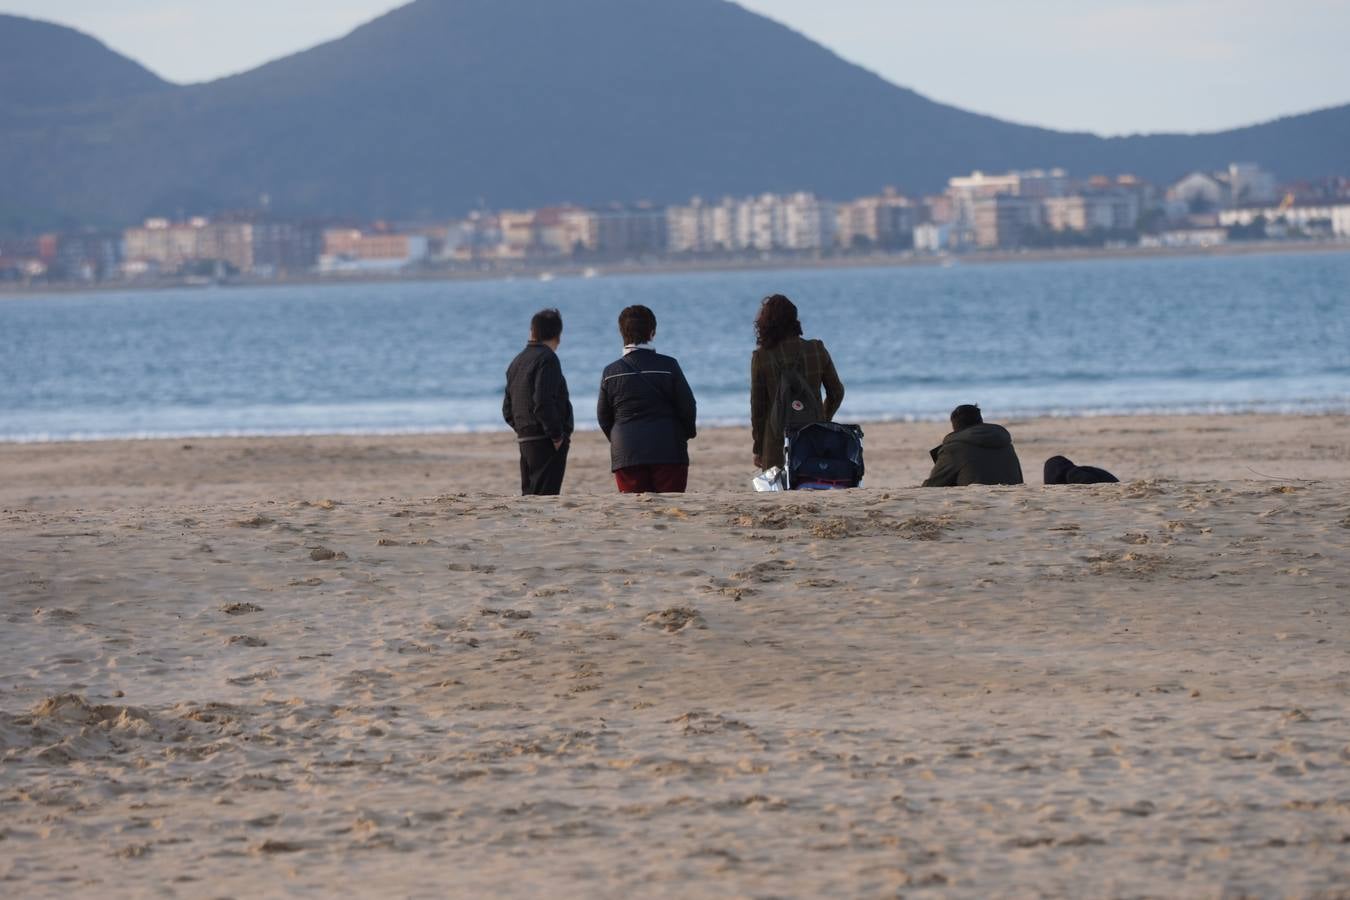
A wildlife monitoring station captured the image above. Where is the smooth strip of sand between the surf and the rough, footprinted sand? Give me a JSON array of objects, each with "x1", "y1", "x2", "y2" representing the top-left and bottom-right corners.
[{"x1": 0, "y1": 413, "x2": 1350, "y2": 510}]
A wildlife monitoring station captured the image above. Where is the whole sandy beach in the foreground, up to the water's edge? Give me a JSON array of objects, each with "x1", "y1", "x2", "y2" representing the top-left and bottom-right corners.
[{"x1": 0, "y1": 416, "x2": 1350, "y2": 897}]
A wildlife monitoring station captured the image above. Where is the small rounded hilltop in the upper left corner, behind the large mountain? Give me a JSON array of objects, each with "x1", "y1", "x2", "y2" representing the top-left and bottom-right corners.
[{"x1": 0, "y1": 15, "x2": 171, "y2": 109}]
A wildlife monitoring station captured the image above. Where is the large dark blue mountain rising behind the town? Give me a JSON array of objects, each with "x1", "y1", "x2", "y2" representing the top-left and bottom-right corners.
[{"x1": 0, "y1": 0, "x2": 1350, "y2": 230}]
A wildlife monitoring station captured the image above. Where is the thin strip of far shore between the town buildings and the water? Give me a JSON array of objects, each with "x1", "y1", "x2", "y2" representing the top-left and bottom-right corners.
[{"x1": 0, "y1": 240, "x2": 1350, "y2": 298}]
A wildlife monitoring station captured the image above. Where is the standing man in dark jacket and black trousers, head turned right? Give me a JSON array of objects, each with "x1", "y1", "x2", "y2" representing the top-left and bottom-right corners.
[{"x1": 502, "y1": 309, "x2": 572, "y2": 497}]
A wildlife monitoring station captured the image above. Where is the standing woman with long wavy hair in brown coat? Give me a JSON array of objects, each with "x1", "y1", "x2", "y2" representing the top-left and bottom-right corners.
[{"x1": 751, "y1": 294, "x2": 844, "y2": 470}]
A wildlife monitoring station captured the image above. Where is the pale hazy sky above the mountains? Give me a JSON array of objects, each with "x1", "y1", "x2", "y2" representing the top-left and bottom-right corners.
[{"x1": 0, "y1": 0, "x2": 1350, "y2": 134}]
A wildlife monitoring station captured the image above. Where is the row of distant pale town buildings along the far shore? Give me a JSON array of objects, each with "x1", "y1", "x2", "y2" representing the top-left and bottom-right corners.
[{"x1": 0, "y1": 163, "x2": 1350, "y2": 283}]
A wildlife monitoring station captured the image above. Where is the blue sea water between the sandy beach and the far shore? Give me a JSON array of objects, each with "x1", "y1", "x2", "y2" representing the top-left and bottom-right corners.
[{"x1": 0, "y1": 252, "x2": 1350, "y2": 441}]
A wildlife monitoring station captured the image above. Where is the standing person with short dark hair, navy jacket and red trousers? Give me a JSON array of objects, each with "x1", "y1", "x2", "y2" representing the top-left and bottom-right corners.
[{"x1": 595, "y1": 306, "x2": 698, "y2": 494}]
